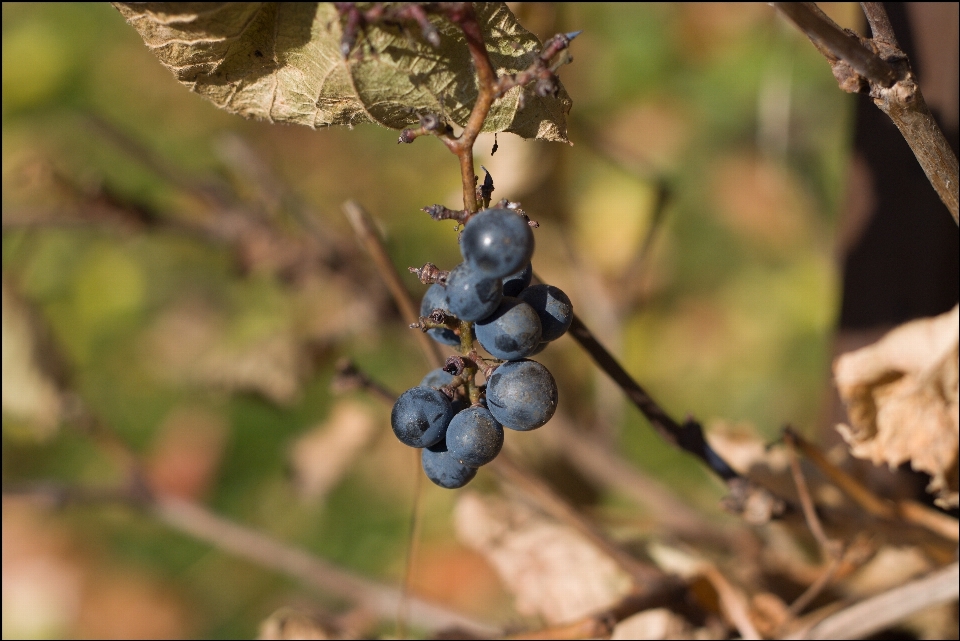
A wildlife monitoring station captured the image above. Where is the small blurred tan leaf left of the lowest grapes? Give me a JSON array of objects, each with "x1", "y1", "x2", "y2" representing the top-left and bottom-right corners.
[{"x1": 290, "y1": 401, "x2": 376, "y2": 499}]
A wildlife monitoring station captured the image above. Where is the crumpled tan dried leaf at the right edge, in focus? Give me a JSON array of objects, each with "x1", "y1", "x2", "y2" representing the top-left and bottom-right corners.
[{"x1": 833, "y1": 306, "x2": 960, "y2": 507}]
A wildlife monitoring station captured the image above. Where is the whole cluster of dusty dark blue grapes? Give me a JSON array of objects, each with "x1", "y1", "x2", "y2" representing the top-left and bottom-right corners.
[{"x1": 390, "y1": 209, "x2": 573, "y2": 489}]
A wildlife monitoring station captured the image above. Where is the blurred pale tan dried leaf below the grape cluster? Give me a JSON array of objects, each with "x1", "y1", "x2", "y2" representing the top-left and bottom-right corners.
[{"x1": 455, "y1": 493, "x2": 631, "y2": 625}]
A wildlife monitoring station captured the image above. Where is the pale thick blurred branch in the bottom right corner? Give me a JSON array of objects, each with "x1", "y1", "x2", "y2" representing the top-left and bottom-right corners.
[{"x1": 788, "y1": 563, "x2": 960, "y2": 639}]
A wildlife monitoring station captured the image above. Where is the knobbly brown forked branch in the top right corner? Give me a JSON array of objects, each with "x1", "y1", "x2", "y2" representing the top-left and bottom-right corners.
[{"x1": 774, "y1": 2, "x2": 960, "y2": 224}]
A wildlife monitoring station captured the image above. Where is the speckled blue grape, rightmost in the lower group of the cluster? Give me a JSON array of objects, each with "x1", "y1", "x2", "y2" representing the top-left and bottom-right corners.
[{"x1": 487, "y1": 360, "x2": 557, "y2": 432}]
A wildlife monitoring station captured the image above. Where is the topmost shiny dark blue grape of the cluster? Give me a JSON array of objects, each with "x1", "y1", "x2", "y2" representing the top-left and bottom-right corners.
[{"x1": 460, "y1": 209, "x2": 533, "y2": 278}]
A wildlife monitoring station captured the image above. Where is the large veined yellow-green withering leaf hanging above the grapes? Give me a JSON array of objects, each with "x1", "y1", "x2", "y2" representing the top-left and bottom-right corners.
[{"x1": 114, "y1": 2, "x2": 572, "y2": 142}]
